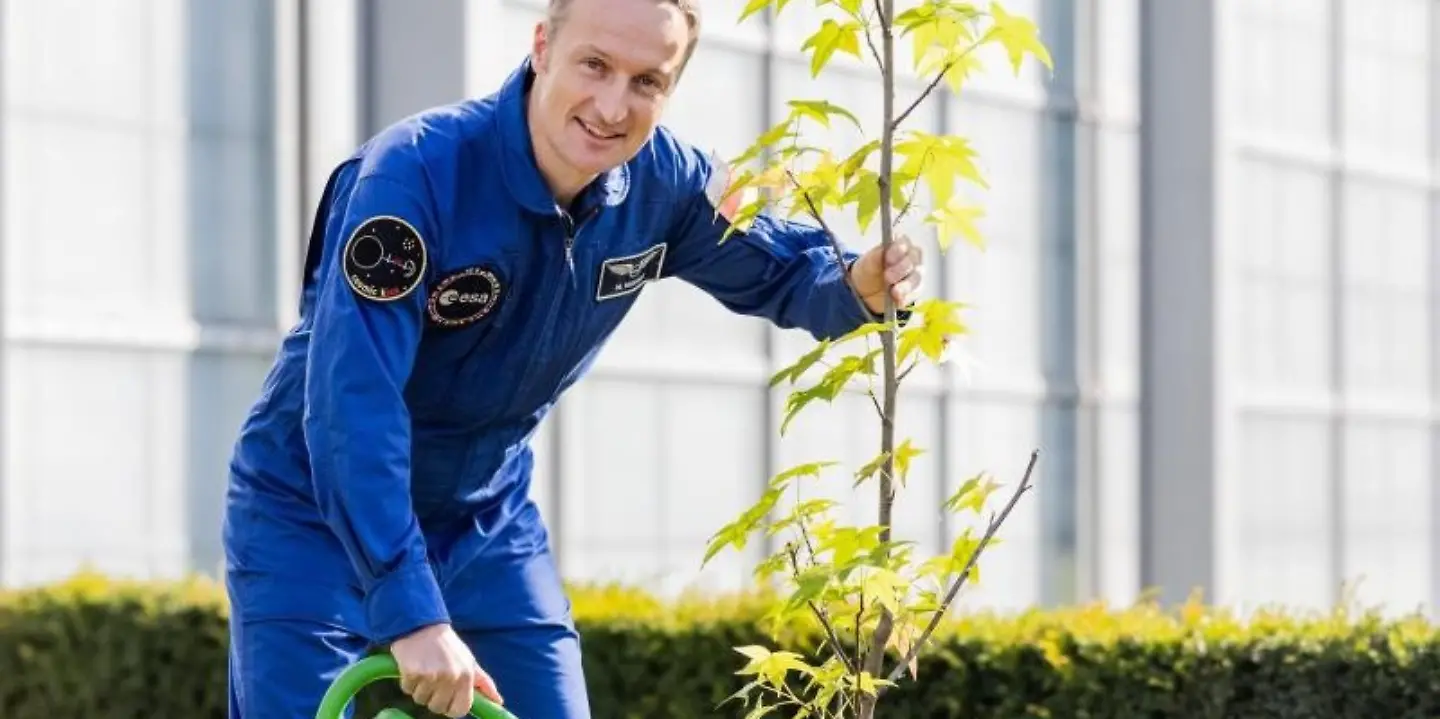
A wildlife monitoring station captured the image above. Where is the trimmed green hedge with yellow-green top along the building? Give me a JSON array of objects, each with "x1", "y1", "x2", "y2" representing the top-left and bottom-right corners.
[{"x1": 0, "y1": 575, "x2": 1440, "y2": 719}]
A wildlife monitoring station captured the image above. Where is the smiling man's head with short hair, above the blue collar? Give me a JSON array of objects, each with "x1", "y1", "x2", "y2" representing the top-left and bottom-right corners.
[{"x1": 530, "y1": 0, "x2": 690, "y2": 188}]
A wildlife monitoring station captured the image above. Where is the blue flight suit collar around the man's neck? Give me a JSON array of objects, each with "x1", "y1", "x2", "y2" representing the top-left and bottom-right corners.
[{"x1": 497, "y1": 56, "x2": 629, "y2": 215}]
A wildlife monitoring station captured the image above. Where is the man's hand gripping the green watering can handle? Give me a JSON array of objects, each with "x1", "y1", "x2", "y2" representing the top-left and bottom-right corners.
[{"x1": 390, "y1": 624, "x2": 501, "y2": 719}]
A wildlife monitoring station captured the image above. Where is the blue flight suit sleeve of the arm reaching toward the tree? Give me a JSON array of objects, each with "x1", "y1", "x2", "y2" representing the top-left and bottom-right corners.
[{"x1": 670, "y1": 151, "x2": 884, "y2": 340}]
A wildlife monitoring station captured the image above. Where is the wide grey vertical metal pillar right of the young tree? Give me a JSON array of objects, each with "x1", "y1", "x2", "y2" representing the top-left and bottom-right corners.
[{"x1": 1140, "y1": 0, "x2": 1220, "y2": 602}]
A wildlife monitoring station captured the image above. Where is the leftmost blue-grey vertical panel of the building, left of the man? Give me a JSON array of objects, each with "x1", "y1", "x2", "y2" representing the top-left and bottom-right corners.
[{"x1": 177, "y1": 0, "x2": 279, "y2": 572}]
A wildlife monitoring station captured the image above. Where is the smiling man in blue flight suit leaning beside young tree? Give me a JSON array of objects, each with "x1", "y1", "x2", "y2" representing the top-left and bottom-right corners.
[{"x1": 225, "y1": 0, "x2": 920, "y2": 719}]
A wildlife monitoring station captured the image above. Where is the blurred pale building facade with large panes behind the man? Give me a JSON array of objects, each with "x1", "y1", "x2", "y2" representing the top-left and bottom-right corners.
[{"x1": 0, "y1": 0, "x2": 1440, "y2": 619}]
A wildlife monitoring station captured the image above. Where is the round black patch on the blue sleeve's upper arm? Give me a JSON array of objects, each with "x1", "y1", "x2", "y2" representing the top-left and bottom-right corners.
[{"x1": 344, "y1": 216, "x2": 428, "y2": 303}]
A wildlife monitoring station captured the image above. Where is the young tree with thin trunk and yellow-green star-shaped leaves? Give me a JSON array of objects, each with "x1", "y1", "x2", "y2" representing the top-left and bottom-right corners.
[{"x1": 704, "y1": 0, "x2": 1051, "y2": 719}]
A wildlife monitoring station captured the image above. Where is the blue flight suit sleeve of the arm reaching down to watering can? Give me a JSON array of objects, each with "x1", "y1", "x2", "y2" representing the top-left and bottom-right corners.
[{"x1": 304, "y1": 165, "x2": 448, "y2": 643}]
